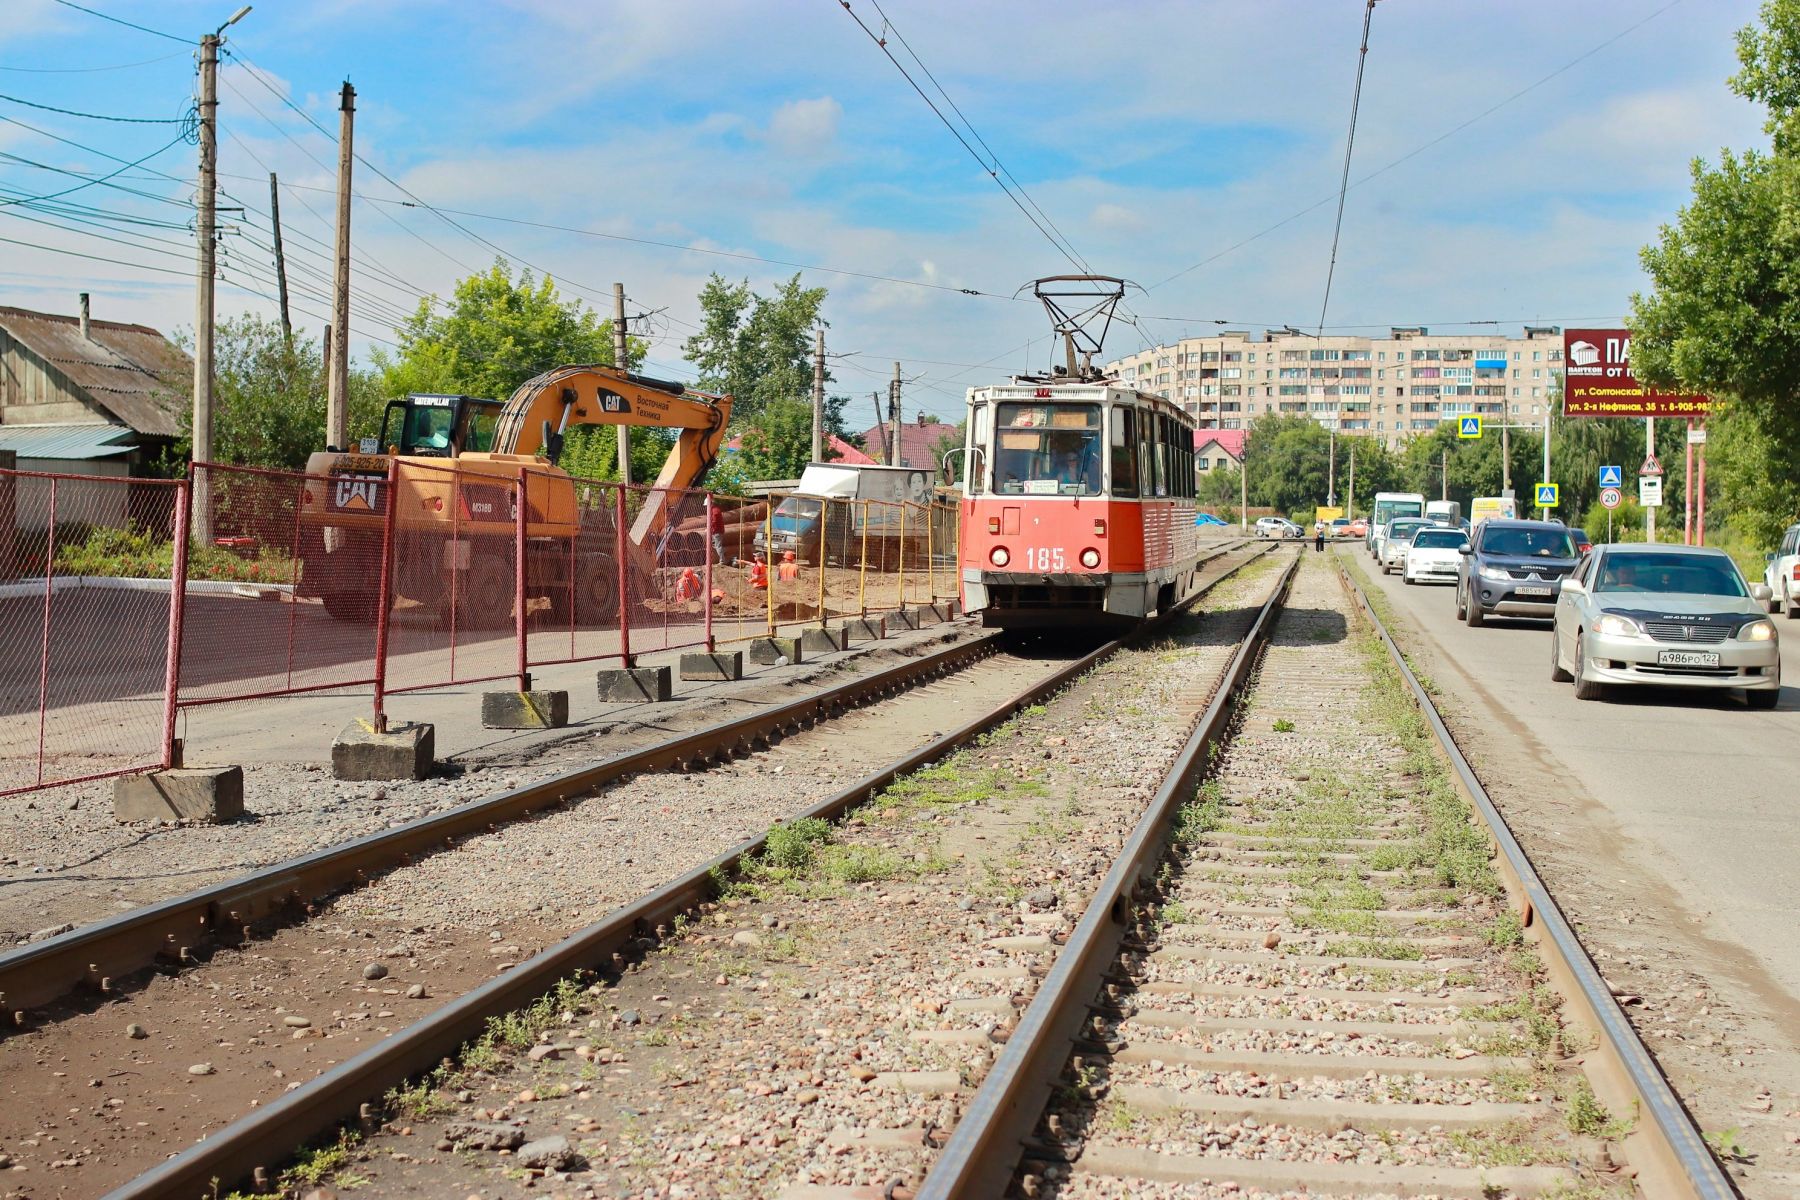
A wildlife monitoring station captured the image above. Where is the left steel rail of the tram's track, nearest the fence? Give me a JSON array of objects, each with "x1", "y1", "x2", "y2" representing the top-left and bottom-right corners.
[{"x1": 0, "y1": 618, "x2": 999, "y2": 1025}]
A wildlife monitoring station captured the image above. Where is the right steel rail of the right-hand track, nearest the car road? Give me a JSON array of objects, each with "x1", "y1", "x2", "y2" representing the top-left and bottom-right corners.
[{"x1": 1334, "y1": 556, "x2": 1737, "y2": 1200}]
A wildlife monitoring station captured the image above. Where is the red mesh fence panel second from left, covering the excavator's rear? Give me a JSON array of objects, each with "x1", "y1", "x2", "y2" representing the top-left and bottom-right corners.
[{"x1": 180, "y1": 462, "x2": 385, "y2": 705}]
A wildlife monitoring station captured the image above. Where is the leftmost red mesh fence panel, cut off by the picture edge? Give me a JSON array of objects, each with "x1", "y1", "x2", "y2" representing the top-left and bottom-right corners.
[{"x1": 0, "y1": 471, "x2": 184, "y2": 793}]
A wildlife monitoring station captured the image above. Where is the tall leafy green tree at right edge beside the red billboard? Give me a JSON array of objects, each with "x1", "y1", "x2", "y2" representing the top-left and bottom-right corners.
[{"x1": 1629, "y1": 0, "x2": 1800, "y2": 545}]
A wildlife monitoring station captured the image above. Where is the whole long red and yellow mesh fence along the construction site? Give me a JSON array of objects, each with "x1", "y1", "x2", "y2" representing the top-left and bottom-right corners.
[{"x1": 0, "y1": 457, "x2": 956, "y2": 793}]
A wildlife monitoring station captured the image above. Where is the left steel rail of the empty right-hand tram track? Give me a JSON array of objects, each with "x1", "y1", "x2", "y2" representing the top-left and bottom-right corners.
[{"x1": 918, "y1": 542, "x2": 1300, "y2": 1200}]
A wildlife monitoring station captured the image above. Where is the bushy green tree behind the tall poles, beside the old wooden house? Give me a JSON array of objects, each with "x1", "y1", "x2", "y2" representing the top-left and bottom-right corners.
[{"x1": 175, "y1": 313, "x2": 383, "y2": 470}]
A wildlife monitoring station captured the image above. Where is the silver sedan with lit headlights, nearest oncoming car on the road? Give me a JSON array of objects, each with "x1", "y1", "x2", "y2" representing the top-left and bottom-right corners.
[{"x1": 1550, "y1": 543, "x2": 1782, "y2": 709}]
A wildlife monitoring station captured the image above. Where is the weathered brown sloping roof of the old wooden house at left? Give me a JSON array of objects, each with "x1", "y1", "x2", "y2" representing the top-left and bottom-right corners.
[{"x1": 0, "y1": 306, "x2": 194, "y2": 437}]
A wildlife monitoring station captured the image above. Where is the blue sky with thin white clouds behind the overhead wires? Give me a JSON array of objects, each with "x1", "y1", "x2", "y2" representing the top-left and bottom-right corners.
[{"x1": 0, "y1": 0, "x2": 1766, "y2": 416}]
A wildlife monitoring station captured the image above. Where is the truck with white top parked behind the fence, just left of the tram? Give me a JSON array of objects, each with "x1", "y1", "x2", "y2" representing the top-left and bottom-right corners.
[{"x1": 754, "y1": 462, "x2": 932, "y2": 565}]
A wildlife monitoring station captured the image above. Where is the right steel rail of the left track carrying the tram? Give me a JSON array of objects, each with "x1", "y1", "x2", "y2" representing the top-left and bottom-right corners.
[{"x1": 104, "y1": 547, "x2": 1292, "y2": 1200}]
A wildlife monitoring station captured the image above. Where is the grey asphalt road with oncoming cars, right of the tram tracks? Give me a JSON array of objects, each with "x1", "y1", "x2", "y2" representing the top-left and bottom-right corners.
[{"x1": 1341, "y1": 549, "x2": 1800, "y2": 1004}]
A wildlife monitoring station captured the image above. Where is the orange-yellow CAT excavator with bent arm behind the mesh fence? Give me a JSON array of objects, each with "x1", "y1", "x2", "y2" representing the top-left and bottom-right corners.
[{"x1": 299, "y1": 365, "x2": 731, "y2": 628}]
